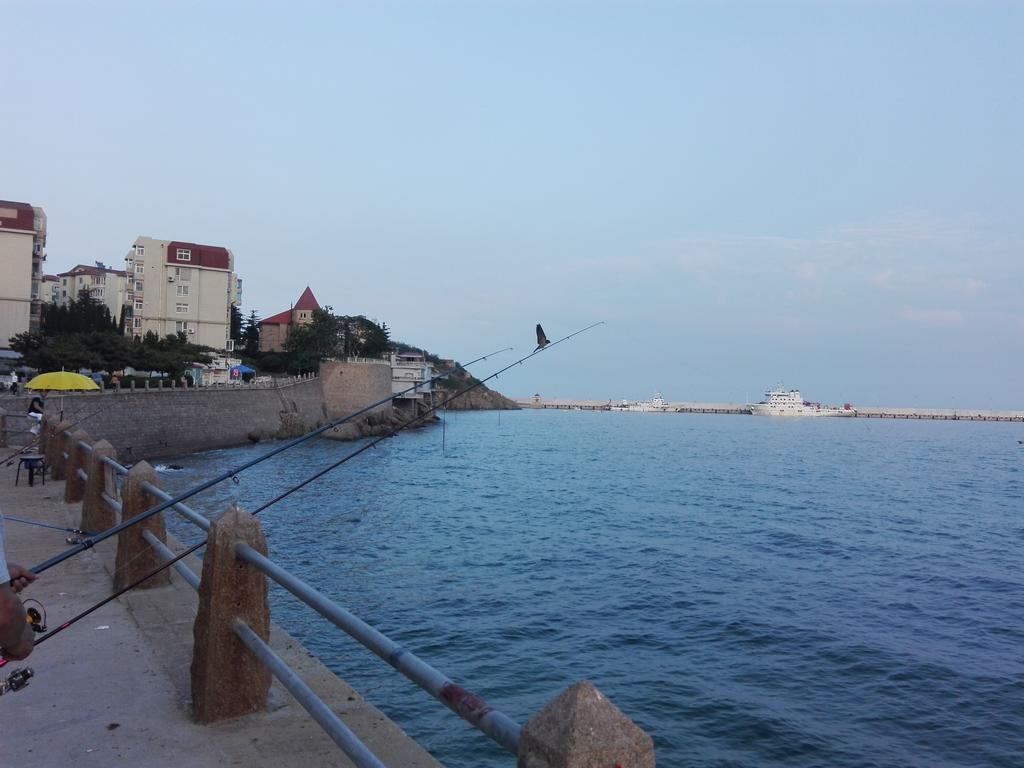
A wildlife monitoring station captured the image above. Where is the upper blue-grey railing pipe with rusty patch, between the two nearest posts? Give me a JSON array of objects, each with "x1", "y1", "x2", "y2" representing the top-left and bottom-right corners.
[{"x1": 234, "y1": 544, "x2": 522, "y2": 755}]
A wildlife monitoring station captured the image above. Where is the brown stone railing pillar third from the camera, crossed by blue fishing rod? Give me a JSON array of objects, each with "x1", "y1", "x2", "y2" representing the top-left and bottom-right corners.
[{"x1": 114, "y1": 462, "x2": 171, "y2": 590}]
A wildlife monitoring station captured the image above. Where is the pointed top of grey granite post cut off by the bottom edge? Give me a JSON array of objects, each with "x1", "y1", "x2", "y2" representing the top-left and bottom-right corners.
[{"x1": 516, "y1": 680, "x2": 654, "y2": 768}]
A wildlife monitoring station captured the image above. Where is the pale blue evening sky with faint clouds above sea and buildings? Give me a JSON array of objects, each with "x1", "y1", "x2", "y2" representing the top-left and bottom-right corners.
[{"x1": 0, "y1": 0, "x2": 1024, "y2": 409}]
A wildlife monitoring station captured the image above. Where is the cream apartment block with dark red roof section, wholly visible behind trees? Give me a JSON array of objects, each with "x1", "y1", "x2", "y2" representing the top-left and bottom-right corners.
[{"x1": 125, "y1": 237, "x2": 241, "y2": 350}]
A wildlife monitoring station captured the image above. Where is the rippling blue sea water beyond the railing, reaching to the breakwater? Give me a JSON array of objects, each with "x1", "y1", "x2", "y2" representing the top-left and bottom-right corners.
[{"x1": 164, "y1": 411, "x2": 1024, "y2": 768}]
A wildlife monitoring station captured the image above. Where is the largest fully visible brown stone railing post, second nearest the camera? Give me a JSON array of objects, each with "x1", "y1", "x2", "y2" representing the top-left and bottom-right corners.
[{"x1": 191, "y1": 505, "x2": 270, "y2": 723}]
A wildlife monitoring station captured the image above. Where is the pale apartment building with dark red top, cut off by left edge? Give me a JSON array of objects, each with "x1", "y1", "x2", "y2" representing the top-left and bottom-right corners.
[{"x1": 0, "y1": 200, "x2": 46, "y2": 349}]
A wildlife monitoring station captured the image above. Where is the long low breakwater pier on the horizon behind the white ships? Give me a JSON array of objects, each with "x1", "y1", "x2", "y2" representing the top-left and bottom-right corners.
[{"x1": 513, "y1": 395, "x2": 1024, "y2": 422}]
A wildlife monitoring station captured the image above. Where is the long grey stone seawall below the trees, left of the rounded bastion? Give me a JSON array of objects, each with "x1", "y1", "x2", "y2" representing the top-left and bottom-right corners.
[{"x1": 46, "y1": 379, "x2": 327, "y2": 462}]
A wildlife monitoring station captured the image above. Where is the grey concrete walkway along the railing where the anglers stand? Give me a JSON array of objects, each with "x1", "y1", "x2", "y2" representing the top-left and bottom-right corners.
[{"x1": 0, "y1": 456, "x2": 440, "y2": 768}]
